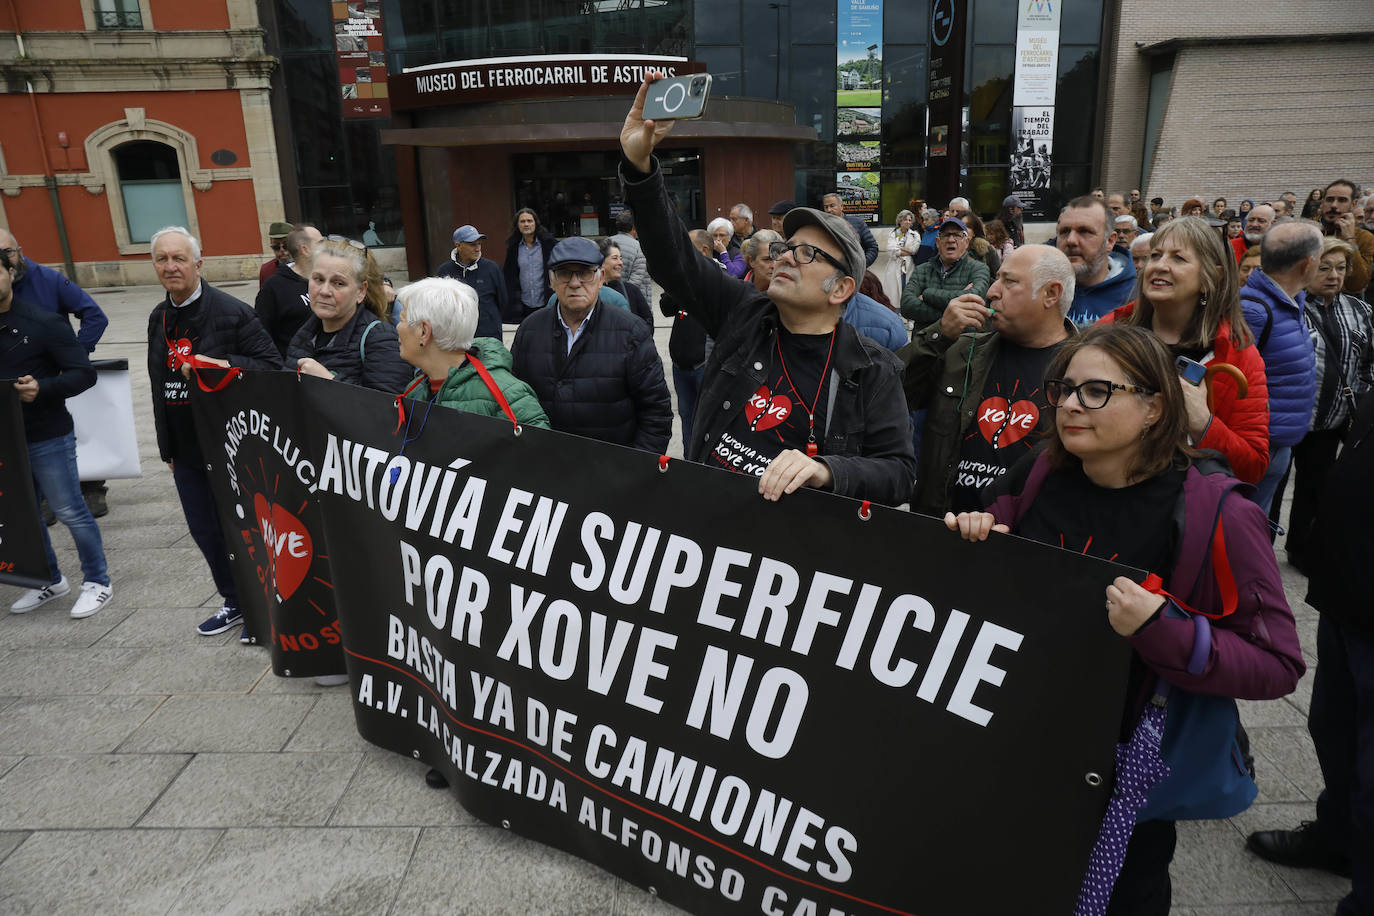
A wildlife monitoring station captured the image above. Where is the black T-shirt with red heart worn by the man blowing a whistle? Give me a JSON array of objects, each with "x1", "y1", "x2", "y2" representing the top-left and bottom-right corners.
[{"x1": 949, "y1": 339, "x2": 1059, "y2": 512}]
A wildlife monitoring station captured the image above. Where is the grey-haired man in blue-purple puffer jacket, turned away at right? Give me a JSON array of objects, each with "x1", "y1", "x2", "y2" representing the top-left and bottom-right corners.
[{"x1": 1241, "y1": 221, "x2": 1322, "y2": 516}]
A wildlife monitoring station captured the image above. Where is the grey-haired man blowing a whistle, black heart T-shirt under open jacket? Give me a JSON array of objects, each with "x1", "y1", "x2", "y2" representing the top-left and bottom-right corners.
[{"x1": 897, "y1": 244, "x2": 1076, "y2": 515}]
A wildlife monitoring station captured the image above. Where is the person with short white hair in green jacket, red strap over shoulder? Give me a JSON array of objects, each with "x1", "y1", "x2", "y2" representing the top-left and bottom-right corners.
[{"x1": 396, "y1": 277, "x2": 548, "y2": 430}]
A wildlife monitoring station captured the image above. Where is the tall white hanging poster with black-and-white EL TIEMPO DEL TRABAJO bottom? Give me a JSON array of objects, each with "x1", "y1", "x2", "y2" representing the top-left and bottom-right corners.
[{"x1": 1007, "y1": 0, "x2": 1062, "y2": 220}]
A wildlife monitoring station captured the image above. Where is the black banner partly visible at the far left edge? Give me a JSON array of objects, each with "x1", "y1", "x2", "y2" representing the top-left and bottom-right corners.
[{"x1": 0, "y1": 379, "x2": 51, "y2": 588}]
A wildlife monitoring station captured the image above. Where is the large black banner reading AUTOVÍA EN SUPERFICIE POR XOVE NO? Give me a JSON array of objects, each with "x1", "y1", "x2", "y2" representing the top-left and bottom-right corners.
[{"x1": 281, "y1": 378, "x2": 1129, "y2": 916}]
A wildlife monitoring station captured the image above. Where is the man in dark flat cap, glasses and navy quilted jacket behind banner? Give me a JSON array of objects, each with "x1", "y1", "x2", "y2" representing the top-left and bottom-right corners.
[{"x1": 511, "y1": 236, "x2": 673, "y2": 455}]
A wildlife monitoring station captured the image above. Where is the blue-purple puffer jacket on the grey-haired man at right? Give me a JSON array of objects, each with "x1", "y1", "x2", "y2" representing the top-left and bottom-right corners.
[{"x1": 1241, "y1": 271, "x2": 1316, "y2": 453}]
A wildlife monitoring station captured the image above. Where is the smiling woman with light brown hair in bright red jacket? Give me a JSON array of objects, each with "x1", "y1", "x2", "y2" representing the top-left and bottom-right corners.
[{"x1": 1102, "y1": 217, "x2": 1270, "y2": 483}]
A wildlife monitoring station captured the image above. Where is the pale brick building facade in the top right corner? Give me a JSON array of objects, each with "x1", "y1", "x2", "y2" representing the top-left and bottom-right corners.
[{"x1": 1101, "y1": 0, "x2": 1374, "y2": 206}]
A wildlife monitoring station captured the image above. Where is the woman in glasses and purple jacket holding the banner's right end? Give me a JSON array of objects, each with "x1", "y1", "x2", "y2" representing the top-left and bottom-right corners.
[{"x1": 945, "y1": 324, "x2": 1305, "y2": 916}]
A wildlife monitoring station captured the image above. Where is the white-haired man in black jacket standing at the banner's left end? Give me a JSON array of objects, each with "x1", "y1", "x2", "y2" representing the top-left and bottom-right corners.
[{"x1": 148, "y1": 227, "x2": 282, "y2": 643}]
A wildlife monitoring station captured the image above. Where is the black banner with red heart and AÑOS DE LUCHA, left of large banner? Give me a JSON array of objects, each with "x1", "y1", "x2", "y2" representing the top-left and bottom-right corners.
[{"x1": 191, "y1": 369, "x2": 352, "y2": 677}]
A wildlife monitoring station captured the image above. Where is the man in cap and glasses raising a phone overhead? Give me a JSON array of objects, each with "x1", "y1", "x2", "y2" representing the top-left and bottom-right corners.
[{"x1": 620, "y1": 76, "x2": 915, "y2": 505}]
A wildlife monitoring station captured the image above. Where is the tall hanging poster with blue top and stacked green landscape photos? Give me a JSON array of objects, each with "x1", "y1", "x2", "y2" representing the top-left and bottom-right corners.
[{"x1": 835, "y1": 0, "x2": 882, "y2": 222}]
